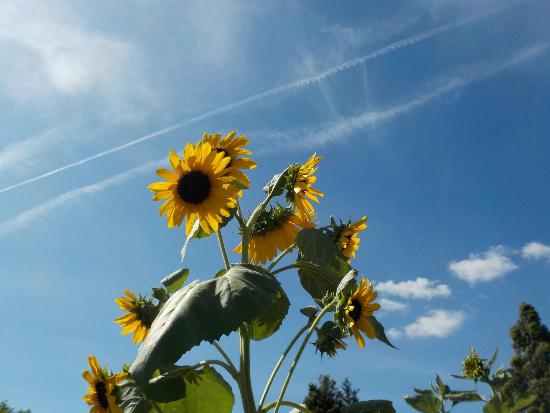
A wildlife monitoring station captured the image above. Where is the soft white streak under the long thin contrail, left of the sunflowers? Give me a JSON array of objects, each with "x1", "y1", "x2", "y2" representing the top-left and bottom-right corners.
[{"x1": 0, "y1": 159, "x2": 166, "y2": 237}]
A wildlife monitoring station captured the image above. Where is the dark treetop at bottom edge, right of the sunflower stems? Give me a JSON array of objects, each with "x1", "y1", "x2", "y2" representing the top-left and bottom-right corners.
[{"x1": 304, "y1": 375, "x2": 359, "y2": 413}]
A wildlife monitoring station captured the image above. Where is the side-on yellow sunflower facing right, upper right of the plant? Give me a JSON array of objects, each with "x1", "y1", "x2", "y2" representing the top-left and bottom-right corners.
[{"x1": 286, "y1": 153, "x2": 324, "y2": 217}]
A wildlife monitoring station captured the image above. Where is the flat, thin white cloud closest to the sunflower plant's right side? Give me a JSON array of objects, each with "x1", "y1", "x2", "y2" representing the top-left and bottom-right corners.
[{"x1": 376, "y1": 277, "x2": 451, "y2": 300}]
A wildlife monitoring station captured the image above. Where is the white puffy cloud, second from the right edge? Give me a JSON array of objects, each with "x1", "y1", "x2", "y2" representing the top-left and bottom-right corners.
[{"x1": 449, "y1": 246, "x2": 518, "y2": 284}]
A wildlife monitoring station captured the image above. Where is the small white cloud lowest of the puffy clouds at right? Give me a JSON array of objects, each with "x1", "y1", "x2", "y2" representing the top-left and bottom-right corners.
[{"x1": 405, "y1": 310, "x2": 464, "y2": 338}]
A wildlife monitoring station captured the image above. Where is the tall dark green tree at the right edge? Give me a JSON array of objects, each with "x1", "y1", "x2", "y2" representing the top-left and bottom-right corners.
[{"x1": 503, "y1": 303, "x2": 550, "y2": 413}]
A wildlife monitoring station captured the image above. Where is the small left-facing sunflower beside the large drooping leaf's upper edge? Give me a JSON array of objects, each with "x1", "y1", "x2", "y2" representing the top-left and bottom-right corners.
[{"x1": 115, "y1": 290, "x2": 157, "y2": 344}]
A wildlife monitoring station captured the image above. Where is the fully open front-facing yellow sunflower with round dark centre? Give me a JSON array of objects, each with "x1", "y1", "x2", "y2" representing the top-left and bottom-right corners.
[{"x1": 147, "y1": 142, "x2": 239, "y2": 234}]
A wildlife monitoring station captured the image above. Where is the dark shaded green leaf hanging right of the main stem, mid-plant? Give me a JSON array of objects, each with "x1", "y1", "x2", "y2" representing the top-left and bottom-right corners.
[{"x1": 296, "y1": 228, "x2": 350, "y2": 299}]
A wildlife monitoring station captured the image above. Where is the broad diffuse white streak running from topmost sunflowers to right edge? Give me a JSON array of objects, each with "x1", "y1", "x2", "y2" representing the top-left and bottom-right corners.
[{"x1": 262, "y1": 43, "x2": 549, "y2": 148}]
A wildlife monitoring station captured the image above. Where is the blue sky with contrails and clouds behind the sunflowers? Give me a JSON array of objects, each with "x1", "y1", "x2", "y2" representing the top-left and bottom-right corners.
[{"x1": 0, "y1": 0, "x2": 550, "y2": 413}]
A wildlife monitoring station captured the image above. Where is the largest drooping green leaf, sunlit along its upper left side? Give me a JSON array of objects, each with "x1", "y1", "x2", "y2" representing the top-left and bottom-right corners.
[{"x1": 130, "y1": 265, "x2": 281, "y2": 385}]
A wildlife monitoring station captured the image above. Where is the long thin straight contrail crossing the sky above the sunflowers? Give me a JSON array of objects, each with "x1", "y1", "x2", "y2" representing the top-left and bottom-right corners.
[{"x1": 0, "y1": 0, "x2": 526, "y2": 193}]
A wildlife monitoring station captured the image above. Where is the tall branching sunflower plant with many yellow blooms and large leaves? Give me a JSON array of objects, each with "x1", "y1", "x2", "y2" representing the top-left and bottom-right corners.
[{"x1": 85, "y1": 131, "x2": 395, "y2": 413}]
